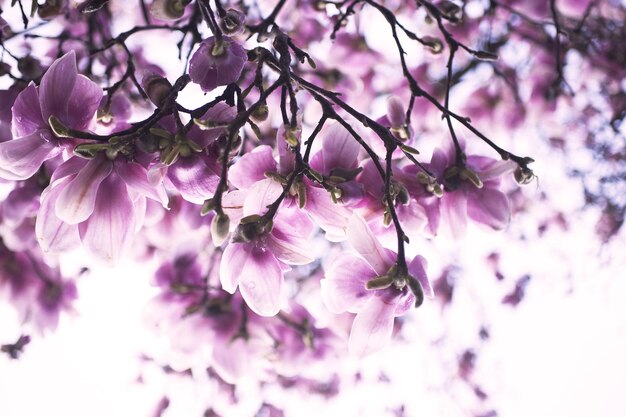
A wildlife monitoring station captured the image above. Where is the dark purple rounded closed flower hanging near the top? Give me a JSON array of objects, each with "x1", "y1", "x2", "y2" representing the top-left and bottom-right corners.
[{"x1": 189, "y1": 36, "x2": 248, "y2": 92}]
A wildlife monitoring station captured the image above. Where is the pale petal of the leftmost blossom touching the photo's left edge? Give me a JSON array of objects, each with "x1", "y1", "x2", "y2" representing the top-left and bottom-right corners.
[{"x1": 0, "y1": 130, "x2": 61, "y2": 180}]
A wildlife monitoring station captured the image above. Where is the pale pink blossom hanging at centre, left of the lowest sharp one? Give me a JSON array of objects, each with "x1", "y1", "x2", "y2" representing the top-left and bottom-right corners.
[{"x1": 220, "y1": 179, "x2": 313, "y2": 316}]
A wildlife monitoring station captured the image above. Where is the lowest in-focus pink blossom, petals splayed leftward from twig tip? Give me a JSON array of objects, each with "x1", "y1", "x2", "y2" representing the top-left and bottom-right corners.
[{"x1": 321, "y1": 215, "x2": 433, "y2": 356}]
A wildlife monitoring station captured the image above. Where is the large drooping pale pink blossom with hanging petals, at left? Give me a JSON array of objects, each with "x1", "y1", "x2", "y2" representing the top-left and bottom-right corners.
[{"x1": 35, "y1": 154, "x2": 167, "y2": 263}]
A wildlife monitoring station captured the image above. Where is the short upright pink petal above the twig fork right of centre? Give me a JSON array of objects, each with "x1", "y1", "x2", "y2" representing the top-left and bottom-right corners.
[{"x1": 322, "y1": 123, "x2": 361, "y2": 173}]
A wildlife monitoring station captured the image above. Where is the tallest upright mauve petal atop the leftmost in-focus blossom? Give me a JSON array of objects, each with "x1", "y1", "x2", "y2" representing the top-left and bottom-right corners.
[{"x1": 39, "y1": 51, "x2": 78, "y2": 123}]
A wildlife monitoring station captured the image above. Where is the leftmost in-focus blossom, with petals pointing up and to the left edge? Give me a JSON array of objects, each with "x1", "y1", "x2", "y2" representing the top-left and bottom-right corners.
[{"x1": 0, "y1": 51, "x2": 102, "y2": 180}]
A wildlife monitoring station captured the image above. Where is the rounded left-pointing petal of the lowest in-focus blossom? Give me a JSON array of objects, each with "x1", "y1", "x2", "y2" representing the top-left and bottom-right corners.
[{"x1": 320, "y1": 255, "x2": 377, "y2": 314}]
